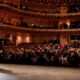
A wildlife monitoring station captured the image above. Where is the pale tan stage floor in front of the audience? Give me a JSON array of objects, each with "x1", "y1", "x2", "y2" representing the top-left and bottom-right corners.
[{"x1": 0, "y1": 64, "x2": 80, "y2": 80}]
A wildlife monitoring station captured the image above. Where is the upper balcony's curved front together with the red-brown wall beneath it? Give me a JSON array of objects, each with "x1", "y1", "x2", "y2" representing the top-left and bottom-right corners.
[{"x1": 0, "y1": 4, "x2": 80, "y2": 27}]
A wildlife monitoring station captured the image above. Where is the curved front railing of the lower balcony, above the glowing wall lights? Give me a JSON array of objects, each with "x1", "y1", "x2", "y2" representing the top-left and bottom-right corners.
[{"x1": 0, "y1": 24, "x2": 80, "y2": 33}]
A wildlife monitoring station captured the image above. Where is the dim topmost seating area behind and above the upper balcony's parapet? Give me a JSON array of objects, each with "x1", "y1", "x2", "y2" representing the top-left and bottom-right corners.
[{"x1": 0, "y1": 0, "x2": 80, "y2": 14}]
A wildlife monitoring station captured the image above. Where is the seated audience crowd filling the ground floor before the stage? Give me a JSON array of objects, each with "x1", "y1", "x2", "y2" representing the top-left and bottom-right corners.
[{"x1": 0, "y1": 43, "x2": 80, "y2": 67}]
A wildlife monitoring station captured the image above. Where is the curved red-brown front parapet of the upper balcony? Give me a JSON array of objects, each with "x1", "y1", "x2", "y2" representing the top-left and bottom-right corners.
[{"x1": 0, "y1": 4, "x2": 80, "y2": 19}]
